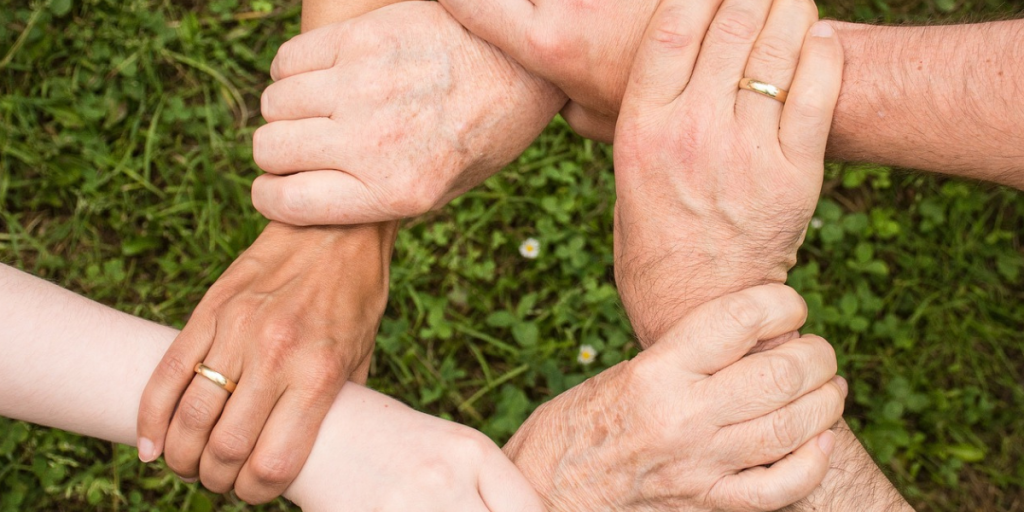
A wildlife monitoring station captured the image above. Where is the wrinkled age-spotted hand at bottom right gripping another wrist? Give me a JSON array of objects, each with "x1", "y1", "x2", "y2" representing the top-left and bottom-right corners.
[{"x1": 505, "y1": 285, "x2": 847, "y2": 512}]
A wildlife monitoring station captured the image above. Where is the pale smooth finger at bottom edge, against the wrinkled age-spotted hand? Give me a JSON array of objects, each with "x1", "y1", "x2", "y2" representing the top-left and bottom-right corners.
[{"x1": 479, "y1": 450, "x2": 546, "y2": 512}]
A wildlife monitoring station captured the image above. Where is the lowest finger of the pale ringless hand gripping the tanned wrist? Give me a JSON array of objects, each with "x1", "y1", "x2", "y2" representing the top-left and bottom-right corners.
[{"x1": 253, "y1": 171, "x2": 395, "y2": 226}]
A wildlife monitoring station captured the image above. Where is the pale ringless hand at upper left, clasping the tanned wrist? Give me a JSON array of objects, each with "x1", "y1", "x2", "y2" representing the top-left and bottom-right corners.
[{"x1": 253, "y1": 2, "x2": 565, "y2": 225}]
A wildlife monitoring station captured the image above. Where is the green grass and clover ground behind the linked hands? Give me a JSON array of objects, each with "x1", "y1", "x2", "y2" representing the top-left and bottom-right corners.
[{"x1": 0, "y1": 0, "x2": 1024, "y2": 511}]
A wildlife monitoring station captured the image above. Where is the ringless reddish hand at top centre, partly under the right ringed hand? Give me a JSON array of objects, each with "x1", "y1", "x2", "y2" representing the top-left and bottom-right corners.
[{"x1": 440, "y1": 0, "x2": 663, "y2": 142}]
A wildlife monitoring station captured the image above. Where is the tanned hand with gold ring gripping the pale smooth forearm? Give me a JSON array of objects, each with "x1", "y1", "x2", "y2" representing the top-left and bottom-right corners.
[{"x1": 138, "y1": 222, "x2": 394, "y2": 503}]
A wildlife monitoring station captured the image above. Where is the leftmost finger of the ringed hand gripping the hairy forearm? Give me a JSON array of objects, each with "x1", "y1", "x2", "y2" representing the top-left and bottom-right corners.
[{"x1": 623, "y1": 0, "x2": 729, "y2": 110}]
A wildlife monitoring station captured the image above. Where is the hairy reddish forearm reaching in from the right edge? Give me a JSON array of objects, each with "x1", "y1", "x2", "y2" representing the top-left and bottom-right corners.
[{"x1": 828, "y1": 20, "x2": 1024, "y2": 188}]
